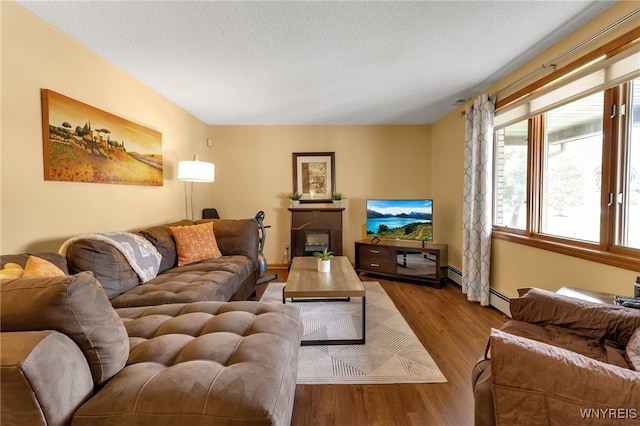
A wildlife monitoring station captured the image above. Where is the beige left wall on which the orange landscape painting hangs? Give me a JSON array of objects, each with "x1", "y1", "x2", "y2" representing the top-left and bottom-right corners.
[{"x1": 0, "y1": 1, "x2": 210, "y2": 253}]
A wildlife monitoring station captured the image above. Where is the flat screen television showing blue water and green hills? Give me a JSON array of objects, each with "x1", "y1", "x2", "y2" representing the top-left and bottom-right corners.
[{"x1": 367, "y1": 199, "x2": 433, "y2": 241}]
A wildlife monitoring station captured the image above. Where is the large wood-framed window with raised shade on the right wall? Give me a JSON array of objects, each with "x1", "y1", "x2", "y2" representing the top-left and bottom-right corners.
[{"x1": 493, "y1": 52, "x2": 640, "y2": 270}]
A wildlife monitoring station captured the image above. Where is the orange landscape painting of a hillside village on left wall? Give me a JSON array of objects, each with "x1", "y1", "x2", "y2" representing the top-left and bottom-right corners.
[{"x1": 42, "y1": 89, "x2": 163, "y2": 186}]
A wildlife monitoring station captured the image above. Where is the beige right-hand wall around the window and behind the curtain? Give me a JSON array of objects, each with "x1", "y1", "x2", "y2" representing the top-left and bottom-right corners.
[{"x1": 431, "y1": 2, "x2": 640, "y2": 297}]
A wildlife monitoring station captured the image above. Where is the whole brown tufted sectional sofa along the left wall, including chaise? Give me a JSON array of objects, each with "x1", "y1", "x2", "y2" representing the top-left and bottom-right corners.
[{"x1": 0, "y1": 220, "x2": 302, "y2": 426}]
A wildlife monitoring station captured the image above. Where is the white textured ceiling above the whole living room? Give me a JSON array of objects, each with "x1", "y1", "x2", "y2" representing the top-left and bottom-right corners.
[{"x1": 19, "y1": 1, "x2": 615, "y2": 125}]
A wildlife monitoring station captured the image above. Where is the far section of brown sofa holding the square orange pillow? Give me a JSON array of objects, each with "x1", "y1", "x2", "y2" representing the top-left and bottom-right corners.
[{"x1": 65, "y1": 219, "x2": 258, "y2": 308}]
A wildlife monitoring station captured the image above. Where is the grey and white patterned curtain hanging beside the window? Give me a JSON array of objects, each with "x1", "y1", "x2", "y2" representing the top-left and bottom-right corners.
[{"x1": 462, "y1": 95, "x2": 495, "y2": 306}]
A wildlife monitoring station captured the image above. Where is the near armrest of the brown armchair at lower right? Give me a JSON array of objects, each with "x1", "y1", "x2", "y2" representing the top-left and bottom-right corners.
[{"x1": 491, "y1": 329, "x2": 640, "y2": 425}]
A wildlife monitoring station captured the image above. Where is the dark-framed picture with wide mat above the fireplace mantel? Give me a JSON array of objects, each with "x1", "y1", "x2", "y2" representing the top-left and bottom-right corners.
[{"x1": 293, "y1": 152, "x2": 336, "y2": 203}]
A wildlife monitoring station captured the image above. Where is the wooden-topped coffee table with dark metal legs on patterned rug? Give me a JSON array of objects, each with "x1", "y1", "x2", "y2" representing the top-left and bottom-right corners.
[{"x1": 282, "y1": 256, "x2": 367, "y2": 346}]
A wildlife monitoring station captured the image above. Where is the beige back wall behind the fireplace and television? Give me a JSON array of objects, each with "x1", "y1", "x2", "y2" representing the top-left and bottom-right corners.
[{"x1": 205, "y1": 126, "x2": 430, "y2": 264}]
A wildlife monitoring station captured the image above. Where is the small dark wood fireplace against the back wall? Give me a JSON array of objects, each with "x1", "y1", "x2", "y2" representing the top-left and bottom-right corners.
[{"x1": 289, "y1": 207, "x2": 344, "y2": 258}]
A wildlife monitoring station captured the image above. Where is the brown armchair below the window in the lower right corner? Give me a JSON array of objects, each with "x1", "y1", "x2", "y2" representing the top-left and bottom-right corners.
[{"x1": 472, "y1": 288, "x2": 640, "y2": 426}]
